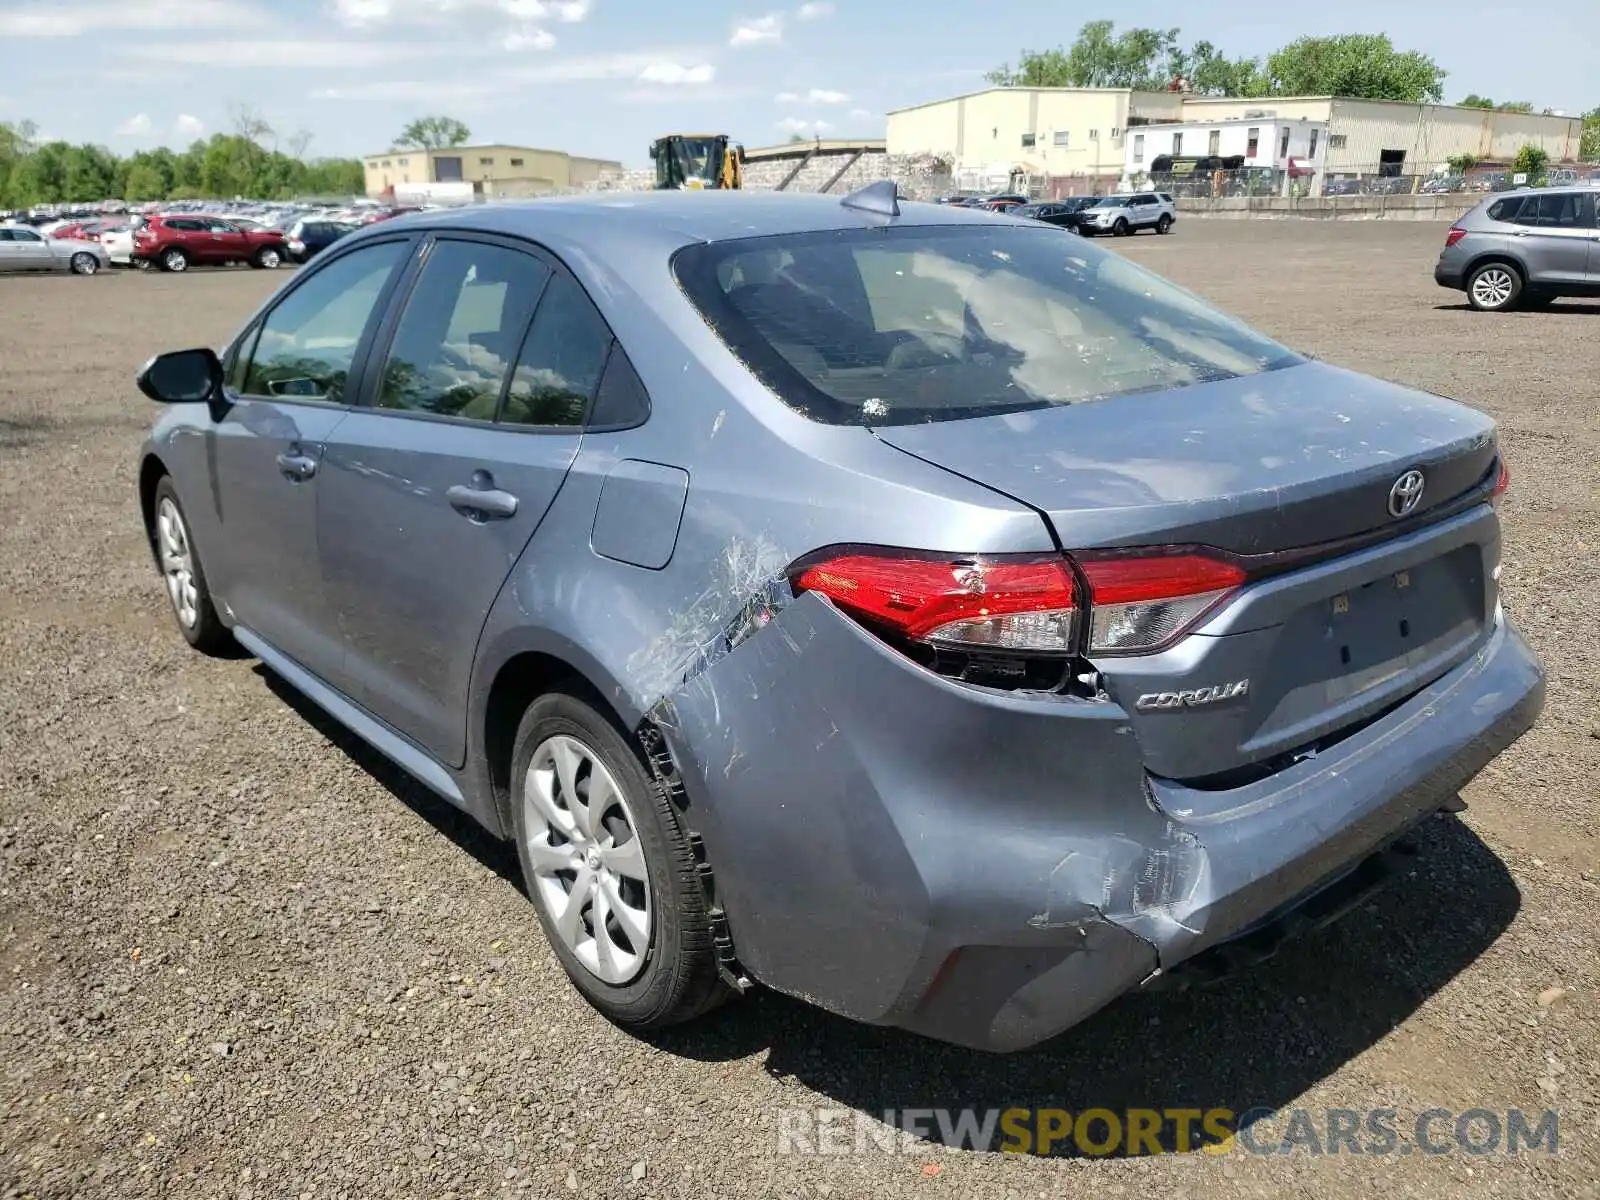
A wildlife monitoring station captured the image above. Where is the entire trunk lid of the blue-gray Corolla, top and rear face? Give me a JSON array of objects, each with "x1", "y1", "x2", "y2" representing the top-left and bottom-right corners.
[{"x1": 877, "y1": 363, "x2": 1499, "y2": 784}]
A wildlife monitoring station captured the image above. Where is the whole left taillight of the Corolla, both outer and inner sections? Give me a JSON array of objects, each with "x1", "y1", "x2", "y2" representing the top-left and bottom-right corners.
[{"x1": 794, "y1": 550, "x2": 1245, "y2": 654}]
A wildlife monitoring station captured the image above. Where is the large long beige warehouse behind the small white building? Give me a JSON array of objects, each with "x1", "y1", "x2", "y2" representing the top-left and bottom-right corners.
[{"x1": 888, "y1": 88, "x2": 1582, "y2": 192}]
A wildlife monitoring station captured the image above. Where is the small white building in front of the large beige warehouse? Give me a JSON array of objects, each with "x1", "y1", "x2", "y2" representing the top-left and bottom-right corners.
[{"x1": 1123, "y1": 117, "x2": 1328, "y2": 194}]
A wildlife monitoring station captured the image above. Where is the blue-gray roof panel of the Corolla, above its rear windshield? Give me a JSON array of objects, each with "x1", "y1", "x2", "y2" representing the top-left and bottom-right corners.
[{"x1": 379, "y1": 190, "x2": 995, "y2": 254}]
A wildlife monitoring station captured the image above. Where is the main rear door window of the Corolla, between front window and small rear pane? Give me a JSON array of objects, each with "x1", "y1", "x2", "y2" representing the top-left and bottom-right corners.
[{"x1": 376, "y1": 240, "x2": 550, "y2": 421}]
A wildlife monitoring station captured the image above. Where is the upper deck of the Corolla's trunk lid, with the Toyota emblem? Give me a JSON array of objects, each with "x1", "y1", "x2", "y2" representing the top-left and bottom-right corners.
[{"x1": 875, "y1": 363, "x2": 1496, "y2": 554}]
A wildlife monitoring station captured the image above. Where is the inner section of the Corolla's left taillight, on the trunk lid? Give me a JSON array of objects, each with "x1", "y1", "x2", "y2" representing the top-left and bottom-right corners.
[{"x1": 1080, "y1": 554, "x2": 1245, "y2": 654}]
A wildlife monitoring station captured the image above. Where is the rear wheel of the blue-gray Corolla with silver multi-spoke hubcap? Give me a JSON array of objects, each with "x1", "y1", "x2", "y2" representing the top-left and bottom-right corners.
[{"x1": 510, "y1": 693, "x2": 728, "y2": 1029}]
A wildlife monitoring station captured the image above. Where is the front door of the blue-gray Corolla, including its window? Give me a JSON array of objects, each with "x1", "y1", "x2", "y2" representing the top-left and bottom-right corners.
[{"x1": 206, "y1": 237, "x2": 414, "y2": 678}]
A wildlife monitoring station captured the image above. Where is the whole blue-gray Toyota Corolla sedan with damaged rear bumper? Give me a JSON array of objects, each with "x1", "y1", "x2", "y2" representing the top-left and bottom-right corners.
[{"x1": 139, "y1": 184, "x2": 1544, "y2": 1050}]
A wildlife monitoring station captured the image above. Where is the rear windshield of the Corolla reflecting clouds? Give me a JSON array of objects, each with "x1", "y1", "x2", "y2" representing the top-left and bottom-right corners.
[{"x1": 674, "y1": 224, "x2": 1301, "y2": 426}]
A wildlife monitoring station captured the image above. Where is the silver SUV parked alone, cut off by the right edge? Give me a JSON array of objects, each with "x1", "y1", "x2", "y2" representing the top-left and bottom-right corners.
[{"x1": 1434, "y1": 187, "x2": 1600, "y2": 312}]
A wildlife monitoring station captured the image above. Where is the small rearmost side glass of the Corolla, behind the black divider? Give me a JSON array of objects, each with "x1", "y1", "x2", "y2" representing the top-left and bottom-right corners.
[{"x1": 501, "y1": 275, "x2": 611, "y2": 426}]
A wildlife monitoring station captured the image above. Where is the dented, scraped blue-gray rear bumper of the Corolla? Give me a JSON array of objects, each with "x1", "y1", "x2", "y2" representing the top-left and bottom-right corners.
[{"x1": 658, "y1": 595, "x2": 1544, "y2": 1051}]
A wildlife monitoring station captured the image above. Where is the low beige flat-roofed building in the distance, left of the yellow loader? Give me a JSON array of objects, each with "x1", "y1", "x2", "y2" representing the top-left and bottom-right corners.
[{"x1": 362, "y1": 146, "x2": 622, "y2": 198}]
